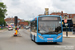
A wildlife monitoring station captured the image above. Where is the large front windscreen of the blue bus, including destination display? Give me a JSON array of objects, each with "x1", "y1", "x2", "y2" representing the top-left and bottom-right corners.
[{"x1": 38, "y1": 17, "x2": 61, "y2": 34}]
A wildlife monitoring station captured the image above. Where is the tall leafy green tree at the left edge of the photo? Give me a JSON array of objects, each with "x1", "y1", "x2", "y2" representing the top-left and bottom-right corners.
[{"x1": 0, "y1": 2, "x2": 7, "y2": 25}]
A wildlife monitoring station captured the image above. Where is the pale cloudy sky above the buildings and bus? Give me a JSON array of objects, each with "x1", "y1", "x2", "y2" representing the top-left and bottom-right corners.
[{"x1": 0, "y1": 0, "x2": 75, "y2": 20}]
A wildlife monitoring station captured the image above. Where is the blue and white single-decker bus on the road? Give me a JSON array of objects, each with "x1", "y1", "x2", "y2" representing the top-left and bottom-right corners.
[{"x1": 30, "y1": 15, "x2": 63, "y2": 43}]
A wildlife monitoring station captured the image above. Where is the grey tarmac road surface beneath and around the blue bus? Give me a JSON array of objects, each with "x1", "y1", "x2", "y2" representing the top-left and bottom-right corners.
[{"x1": 0, "y1": 29, "x2": 75, "y2": 50}]
